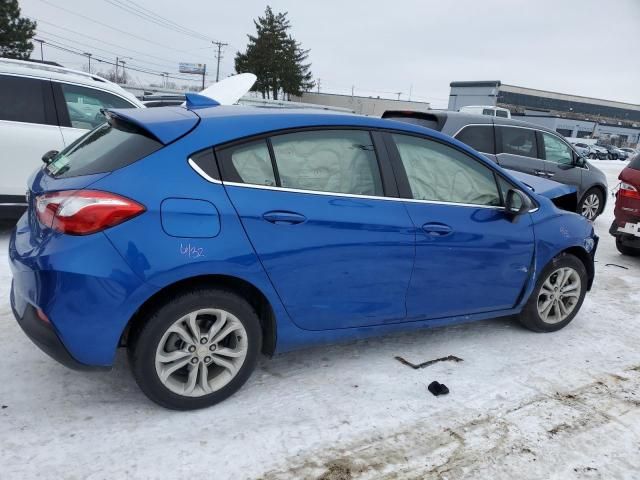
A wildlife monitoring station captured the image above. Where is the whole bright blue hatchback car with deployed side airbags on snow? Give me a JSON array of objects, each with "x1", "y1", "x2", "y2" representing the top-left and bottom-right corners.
[{"x1": 9, "y1": 100, "x2": 598, "y2": 410}]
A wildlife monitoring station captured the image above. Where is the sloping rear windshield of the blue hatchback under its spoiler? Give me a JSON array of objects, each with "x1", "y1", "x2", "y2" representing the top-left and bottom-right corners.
[{"x1": 46, "y1": 119, "x2": 162, "y2": 178}]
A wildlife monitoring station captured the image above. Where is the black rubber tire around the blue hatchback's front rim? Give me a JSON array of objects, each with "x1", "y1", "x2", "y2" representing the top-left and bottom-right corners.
[{"x1": 518, "y1": 253, "x2": 588, "y2": 332}]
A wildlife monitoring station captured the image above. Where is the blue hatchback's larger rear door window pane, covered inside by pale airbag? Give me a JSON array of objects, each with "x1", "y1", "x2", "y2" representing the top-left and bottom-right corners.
[{"x1": 271, "y1": 130, "x2": 383, "y2": 196}]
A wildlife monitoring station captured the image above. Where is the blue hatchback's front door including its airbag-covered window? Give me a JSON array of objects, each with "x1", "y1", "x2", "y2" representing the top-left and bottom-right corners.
[{"x1": 386, "y1": 129, "x2": 534, "y2": 319}]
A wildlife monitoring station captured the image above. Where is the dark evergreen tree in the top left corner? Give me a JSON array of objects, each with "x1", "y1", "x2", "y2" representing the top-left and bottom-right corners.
[{"x1": 0, "y1": 0, "x2": 36, "y2": 60}]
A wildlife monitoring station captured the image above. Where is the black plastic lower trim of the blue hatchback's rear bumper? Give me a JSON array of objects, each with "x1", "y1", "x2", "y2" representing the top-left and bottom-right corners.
[{"x1": 11, "y1": 285, "x2": 109, "y2": 370}]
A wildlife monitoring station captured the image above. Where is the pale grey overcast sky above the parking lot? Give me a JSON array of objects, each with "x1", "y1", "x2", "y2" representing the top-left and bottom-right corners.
[{"x1": 20, "y1": 0, "x2": 640, "y2": 107}]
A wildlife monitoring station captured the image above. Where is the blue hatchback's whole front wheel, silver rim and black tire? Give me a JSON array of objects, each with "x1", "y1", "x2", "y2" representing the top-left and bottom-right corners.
[{"x1": 519, "y1": 254, "x2": 588, "y2": 332}]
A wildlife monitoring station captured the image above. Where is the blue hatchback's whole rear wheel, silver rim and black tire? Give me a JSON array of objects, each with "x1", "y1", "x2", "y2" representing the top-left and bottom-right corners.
[{"x1": 129, "y1": 289, "x2": 262, "y2": 410}]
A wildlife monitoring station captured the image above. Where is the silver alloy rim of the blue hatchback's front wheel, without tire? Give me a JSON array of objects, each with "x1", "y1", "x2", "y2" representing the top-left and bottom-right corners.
[{"x1": 538, "y1": 267, "x2": 582, "y2": 324}]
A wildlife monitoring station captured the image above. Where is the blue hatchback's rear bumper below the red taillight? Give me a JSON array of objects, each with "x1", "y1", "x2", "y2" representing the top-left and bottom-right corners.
[{"x1": 9, "y1": 215, "x2": 154, "y2": 369}]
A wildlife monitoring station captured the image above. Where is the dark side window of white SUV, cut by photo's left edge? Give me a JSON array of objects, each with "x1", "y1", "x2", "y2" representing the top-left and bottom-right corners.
[{"x1": 0, "y1": 75, "x2": 56, "y2": 125}]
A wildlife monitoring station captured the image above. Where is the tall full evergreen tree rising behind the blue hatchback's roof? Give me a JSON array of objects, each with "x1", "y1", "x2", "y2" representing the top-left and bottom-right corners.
[{"x1": 235, "y1": 7, "x2": 314, "y2": 100}]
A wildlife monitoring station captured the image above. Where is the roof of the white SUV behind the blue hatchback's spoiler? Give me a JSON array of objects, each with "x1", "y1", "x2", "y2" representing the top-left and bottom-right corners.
[{"x1": 0, "y1": 58, "x2": 142, "y2": 107}]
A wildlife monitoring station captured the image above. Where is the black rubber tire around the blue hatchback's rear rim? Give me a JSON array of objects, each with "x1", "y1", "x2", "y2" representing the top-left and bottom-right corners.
[{"x1": 127, "y1": 288, "x2": 262, "y2": 410}]
